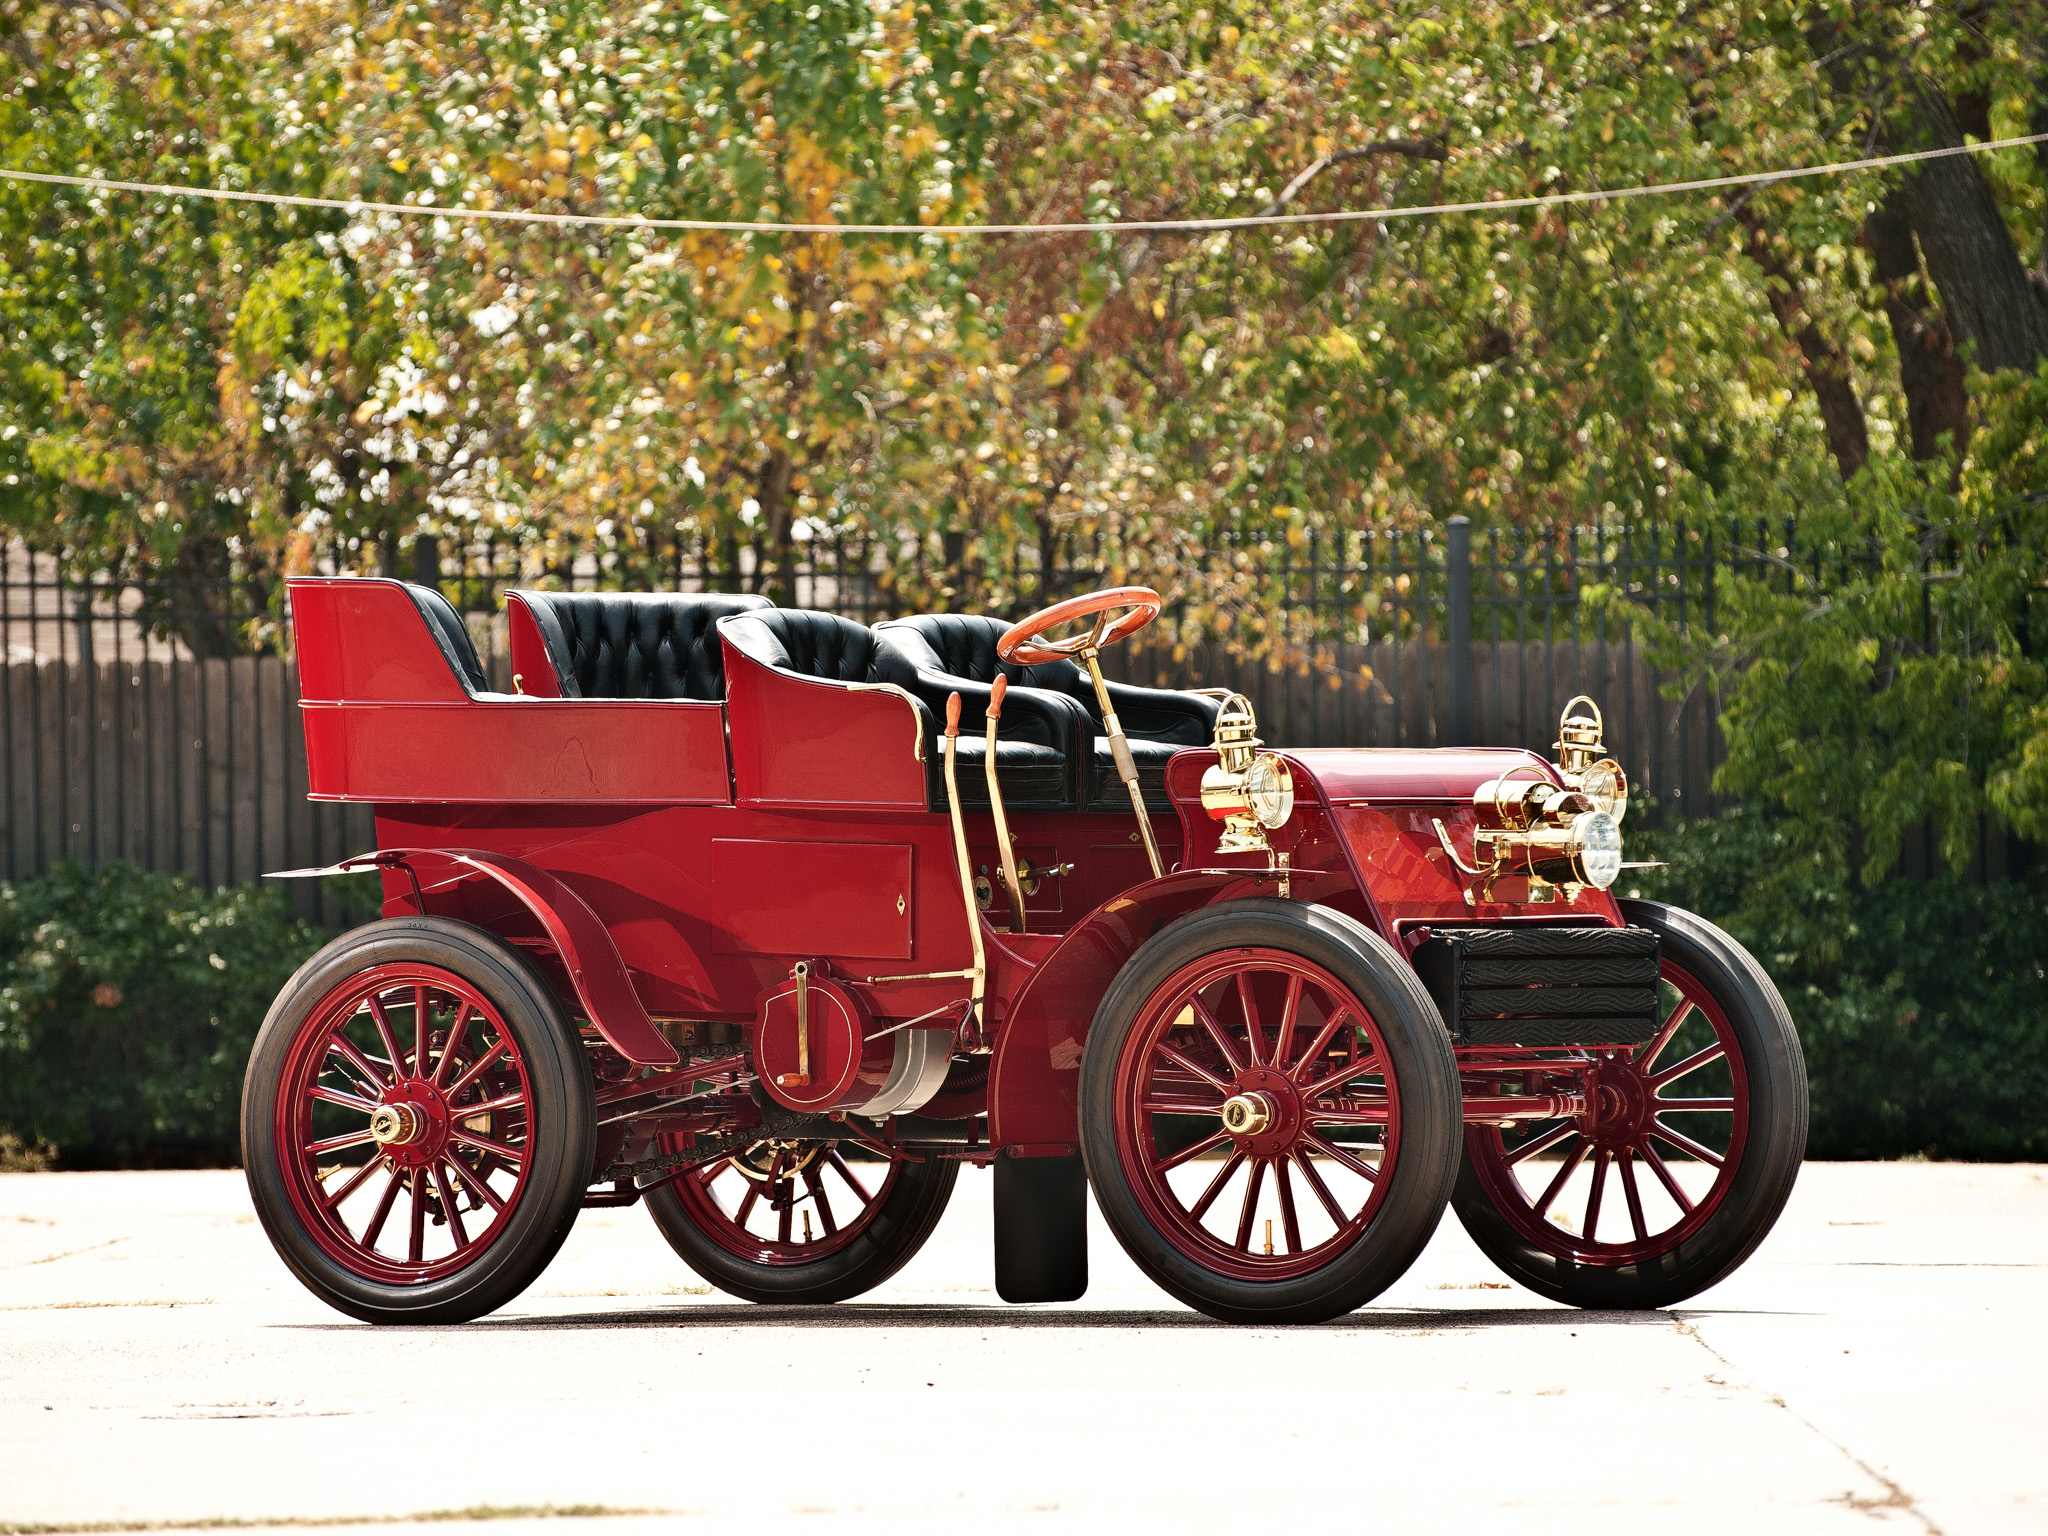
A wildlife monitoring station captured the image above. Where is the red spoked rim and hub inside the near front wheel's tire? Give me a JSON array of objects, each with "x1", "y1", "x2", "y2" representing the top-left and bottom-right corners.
[{"x1": 1116, "y1": 948, "x2": 1401, "y2": 1280}]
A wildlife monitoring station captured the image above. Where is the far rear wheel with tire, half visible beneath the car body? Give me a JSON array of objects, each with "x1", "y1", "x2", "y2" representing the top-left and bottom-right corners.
[{"x1": 647, "y1": 1137, "x2": 958, "y2": 1303}]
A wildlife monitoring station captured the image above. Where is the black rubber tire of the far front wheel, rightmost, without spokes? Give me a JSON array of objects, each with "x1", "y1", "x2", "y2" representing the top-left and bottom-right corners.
[{"x1": 1452, "y1": 901, "x2": 1806, "y2": 1311}]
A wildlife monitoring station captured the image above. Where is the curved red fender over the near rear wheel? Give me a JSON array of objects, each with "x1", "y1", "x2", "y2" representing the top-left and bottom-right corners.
[{"x1": 272, "y1": 848, "x2": 682, "y2": 1067}]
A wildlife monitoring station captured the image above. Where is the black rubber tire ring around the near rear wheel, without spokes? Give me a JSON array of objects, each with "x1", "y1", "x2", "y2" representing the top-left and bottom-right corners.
[{"x1": 242, "y1": 918, "x2": 598, "y2": 1323}]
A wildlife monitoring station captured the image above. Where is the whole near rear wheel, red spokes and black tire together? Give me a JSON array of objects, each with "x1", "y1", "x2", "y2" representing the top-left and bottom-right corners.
[{"x1": 242, "y1": 918, "x2": 596, "y2": 1323}]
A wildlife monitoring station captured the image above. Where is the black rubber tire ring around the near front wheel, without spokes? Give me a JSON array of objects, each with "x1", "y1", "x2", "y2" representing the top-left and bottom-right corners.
[{"x1": 1081, "y1": 897, "x2": 1464, "y2": 1323}]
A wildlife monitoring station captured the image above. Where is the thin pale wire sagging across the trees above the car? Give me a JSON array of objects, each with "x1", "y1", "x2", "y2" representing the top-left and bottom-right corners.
[{"x1": 0, "y1": 133, "x2": 2048, "y2": 240}]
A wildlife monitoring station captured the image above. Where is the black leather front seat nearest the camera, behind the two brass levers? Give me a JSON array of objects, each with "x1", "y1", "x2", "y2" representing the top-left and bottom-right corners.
[{"x1": 719, "y1": 608, "x2": 1077, "y2": 811}]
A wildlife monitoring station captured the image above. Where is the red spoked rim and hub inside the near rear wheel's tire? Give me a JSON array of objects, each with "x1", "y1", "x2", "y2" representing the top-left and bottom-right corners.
[{"x1": 272, "y1": 965, "x2": 532, "y2": 1284}]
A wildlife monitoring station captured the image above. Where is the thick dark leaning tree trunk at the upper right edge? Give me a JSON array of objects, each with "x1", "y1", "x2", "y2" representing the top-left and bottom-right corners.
[{"x1": 1896, "y1": 80, "x2": 2048, "y2": 373}]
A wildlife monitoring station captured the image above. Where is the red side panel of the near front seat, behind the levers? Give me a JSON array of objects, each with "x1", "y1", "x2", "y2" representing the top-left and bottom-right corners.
[{"x1": 719, "y1": 635, "x2": 926, "y2": 811}]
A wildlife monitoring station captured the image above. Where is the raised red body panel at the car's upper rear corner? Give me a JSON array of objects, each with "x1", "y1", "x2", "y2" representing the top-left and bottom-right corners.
[{"x1": 291, "y1": 575, "x2": 467, "y2": 702}]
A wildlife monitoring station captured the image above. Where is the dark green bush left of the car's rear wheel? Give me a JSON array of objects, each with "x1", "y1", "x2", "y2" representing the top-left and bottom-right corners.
[{"x1": 0, "y1": 864, "x2": 328, "y2": 1167}]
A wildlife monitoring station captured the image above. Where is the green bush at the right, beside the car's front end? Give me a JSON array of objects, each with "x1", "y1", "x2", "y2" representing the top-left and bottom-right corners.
[{"x1": 1630, "y1": 809, "x2": 2048, "y2": 1159}]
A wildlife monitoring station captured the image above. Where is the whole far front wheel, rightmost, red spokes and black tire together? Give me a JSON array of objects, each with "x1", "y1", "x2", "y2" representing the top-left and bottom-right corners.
[{"x1": 1452, "y1": 901, "x2": 1806, "y2": 1309}]
